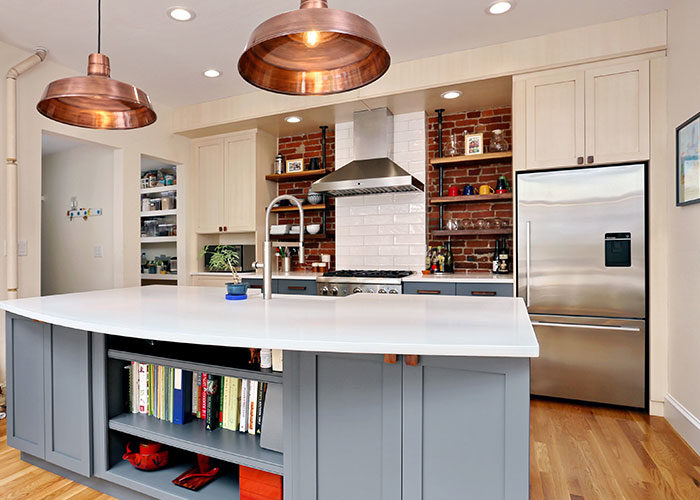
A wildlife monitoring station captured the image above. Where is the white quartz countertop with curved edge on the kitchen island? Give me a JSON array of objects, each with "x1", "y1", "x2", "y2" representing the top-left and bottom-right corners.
[{"x1": 0, "y1": 285, "x2": 539, "y2": 357}]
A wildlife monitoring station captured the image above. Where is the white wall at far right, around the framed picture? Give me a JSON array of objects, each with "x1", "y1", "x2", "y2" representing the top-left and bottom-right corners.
[{"x1": 666, "y1": 0, "x2": 700, "y2": 453}]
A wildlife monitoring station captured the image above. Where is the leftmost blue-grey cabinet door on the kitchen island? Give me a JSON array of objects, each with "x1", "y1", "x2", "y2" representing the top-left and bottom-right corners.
[{"x1": 5, "y1": 314, "x2": 48, "y2": 458}]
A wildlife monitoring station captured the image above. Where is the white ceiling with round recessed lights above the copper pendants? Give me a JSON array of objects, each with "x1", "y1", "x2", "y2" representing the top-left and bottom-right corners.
[{"x1": 0, "y1": 0, "x2": 668, "y2": 106}]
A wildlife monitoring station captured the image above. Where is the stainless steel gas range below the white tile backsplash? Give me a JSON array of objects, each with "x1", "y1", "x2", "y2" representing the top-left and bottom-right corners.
[{"x1": 316, "y1": 270, "x2": 413, "y2": 296}]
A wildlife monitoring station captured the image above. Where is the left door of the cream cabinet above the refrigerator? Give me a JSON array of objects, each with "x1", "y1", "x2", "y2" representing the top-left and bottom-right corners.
[{"x1": 526, "y1": 71, "x2": 585, "y2": 169}]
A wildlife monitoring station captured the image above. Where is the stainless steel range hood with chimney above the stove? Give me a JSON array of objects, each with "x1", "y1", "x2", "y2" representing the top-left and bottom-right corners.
[{"x1": 311, "y1": 108, "x2": 424, "y2": 197}]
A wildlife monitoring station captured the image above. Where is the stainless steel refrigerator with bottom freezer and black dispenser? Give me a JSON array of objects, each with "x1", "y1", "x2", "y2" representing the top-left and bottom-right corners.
[{"x1": 517, "y1": 165, "x2": 647, "y2": 408}]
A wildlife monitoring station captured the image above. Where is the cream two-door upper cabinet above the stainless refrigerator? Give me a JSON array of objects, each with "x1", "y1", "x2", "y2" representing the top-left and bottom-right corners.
[{"x1": 513, "y1": 60, "x2": 650, "y2": 170}]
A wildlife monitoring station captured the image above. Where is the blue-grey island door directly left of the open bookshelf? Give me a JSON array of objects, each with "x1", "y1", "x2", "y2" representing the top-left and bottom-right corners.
[{"x1": 44, "y1": 325, "x2": 92, "y2": 476}]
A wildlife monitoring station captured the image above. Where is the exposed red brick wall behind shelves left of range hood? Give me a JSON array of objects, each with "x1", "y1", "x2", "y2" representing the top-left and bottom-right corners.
[{"x1": 278, "y1": 128, "x2": 335, "y2": 271}]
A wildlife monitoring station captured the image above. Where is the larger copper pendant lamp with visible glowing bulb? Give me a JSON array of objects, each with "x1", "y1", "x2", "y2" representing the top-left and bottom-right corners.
[{"x1": 238, "y1": 0, "x2": 391, "y2": 95}]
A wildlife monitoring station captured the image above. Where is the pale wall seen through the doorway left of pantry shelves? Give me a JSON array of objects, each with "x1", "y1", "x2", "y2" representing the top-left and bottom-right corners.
[{"x1": 41, "y1": 145, "x2": 114, "y2": 295}]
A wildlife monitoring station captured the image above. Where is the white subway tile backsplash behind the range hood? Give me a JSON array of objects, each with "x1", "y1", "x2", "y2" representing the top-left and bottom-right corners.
[{"x1": 335, "y1": 112, "x2": 426, "y2": 271}]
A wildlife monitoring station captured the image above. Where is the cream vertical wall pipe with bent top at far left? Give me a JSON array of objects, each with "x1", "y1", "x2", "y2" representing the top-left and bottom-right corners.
[{"x1": 5, "y1": 49, "x2": 47, "y2": 299}]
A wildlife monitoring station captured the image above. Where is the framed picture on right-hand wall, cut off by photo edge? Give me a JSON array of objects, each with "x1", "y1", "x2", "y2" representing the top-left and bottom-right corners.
[{"x1": 676, "y1": 113, "x2": 700, "y2": 207}]
